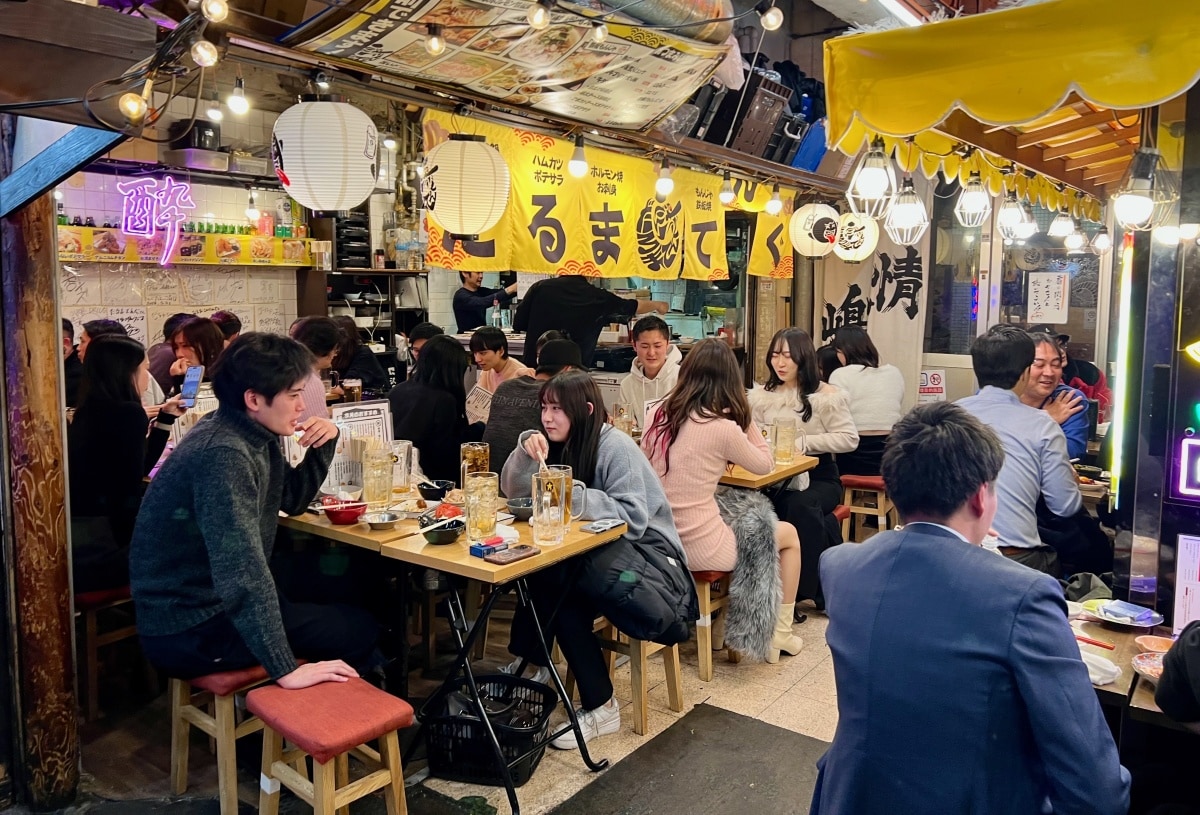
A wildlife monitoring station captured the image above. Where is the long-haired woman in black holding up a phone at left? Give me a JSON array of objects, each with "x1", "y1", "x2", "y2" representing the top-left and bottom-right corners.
[{"x1": 67, "y1": 335, "x2": 185, "y2": 593}]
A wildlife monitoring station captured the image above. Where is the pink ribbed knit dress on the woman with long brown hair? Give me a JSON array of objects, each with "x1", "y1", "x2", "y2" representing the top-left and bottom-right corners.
[{"x1": 642, "y1": 419, "x2": 774, "y2": 571}]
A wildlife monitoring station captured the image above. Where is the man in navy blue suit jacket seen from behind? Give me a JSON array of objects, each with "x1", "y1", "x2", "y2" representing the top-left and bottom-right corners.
[{"x1": 811, "y1": 402, "x2": 1129, "y2": 815}]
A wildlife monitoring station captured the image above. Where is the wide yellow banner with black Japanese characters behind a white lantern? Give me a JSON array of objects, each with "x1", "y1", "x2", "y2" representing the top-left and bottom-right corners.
[{"x1": 425, "y1": 110, "x2": 728, "y2": 280}]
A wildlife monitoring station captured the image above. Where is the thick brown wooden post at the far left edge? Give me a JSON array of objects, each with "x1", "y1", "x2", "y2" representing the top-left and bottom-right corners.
[{"x1": 0, "y1": 115, "x2": 79, "y2": 809}]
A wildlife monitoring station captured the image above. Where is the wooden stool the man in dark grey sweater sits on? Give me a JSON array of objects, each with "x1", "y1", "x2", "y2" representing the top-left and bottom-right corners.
[{"x1": 169, "y1": 666, "x2": 269, "y2": 815}]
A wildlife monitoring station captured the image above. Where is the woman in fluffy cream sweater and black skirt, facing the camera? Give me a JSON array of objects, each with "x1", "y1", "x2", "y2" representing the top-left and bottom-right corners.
[{"x1": 749, "y1": 328, "x2": 858, "y2": 604}]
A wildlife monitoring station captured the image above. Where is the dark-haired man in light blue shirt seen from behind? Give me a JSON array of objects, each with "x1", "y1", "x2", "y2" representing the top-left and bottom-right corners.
[{"x1": 958, "y1": 325, "x2": 1082, "y2": 577}]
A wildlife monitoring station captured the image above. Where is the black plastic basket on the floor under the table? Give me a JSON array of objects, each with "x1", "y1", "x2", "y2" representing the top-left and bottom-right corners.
[{"x1": 424, "y1": 673, "x2": 558, "y2": 786}]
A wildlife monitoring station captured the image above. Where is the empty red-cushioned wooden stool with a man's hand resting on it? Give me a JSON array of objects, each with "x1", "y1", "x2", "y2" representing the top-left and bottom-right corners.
[{"x1": 246, "y1": 678, "x2": 413, "y2": 815}]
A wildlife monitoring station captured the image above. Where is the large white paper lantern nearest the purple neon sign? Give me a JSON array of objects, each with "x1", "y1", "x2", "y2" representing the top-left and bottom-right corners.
[{"x1": 271, "y1": 102, "x2": 379, "y2": 212}]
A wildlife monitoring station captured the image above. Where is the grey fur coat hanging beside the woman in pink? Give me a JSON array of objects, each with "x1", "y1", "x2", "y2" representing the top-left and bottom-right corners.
[{"x1": 716, "y1": 487, "x2": 784, "y2": 661}]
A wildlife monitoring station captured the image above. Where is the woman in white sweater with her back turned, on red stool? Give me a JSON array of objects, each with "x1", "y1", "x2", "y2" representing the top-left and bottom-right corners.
[{"x1": 829, "y1": 325, "x2": 904, "y2": 475}]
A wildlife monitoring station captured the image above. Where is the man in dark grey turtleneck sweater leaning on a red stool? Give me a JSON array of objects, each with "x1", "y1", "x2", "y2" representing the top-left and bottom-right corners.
[{"x1": 130, "y1": 332, "x2": 376, "y2": 688}]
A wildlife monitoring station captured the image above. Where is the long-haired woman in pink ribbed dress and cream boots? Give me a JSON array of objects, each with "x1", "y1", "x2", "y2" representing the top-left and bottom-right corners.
[{"x1": 642, "y1": 340, "x2": 803, "y2": 663}]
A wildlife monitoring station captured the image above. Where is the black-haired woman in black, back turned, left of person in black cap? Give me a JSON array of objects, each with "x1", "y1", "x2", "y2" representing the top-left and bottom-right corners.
[{"x1": 388, "y1": 334, "x2": 482, "y2": 483}]
